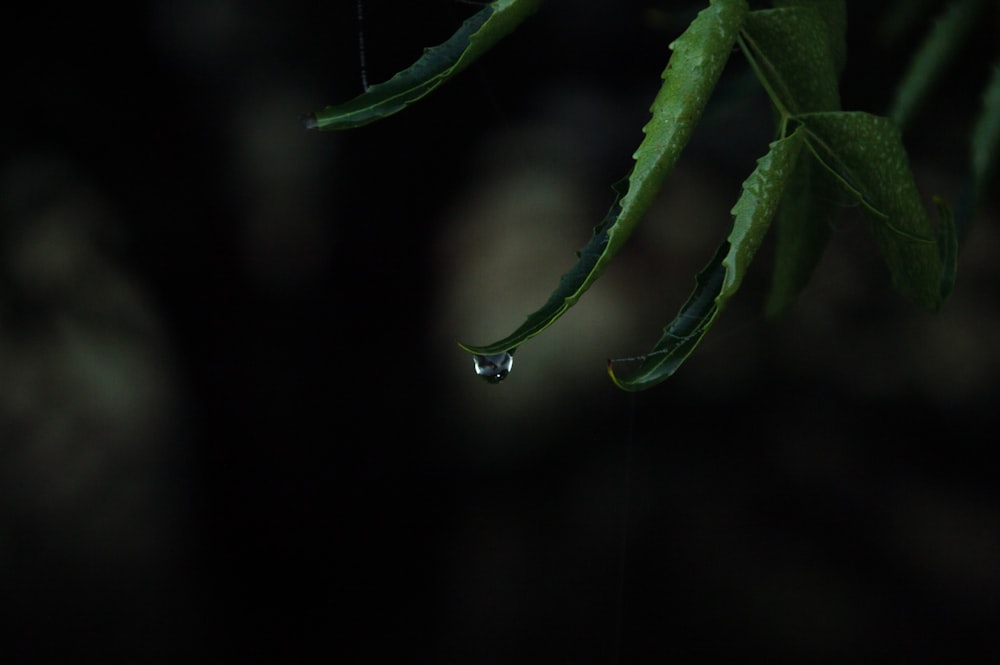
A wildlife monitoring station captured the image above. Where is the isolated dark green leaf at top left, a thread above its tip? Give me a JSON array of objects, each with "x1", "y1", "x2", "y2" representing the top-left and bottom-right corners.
[{"x1": 305, "y1": 0, "x2": 541, "y2": 130}]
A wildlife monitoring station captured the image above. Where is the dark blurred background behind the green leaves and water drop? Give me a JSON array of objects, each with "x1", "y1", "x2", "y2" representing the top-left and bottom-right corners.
[{"x1": 0, "y1": 0, "x2": 1000, "y2": 663}]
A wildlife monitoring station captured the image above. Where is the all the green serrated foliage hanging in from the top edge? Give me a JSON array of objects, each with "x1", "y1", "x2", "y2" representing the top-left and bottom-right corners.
[{"x1": 308, "y1": 0, "x2": 1000, "y2": 390}]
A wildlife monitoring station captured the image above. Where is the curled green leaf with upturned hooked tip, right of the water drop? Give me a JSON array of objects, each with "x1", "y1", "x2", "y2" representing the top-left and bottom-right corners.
[{"x1": 608, "y1": 130, "x2": 803, "y2": 392}]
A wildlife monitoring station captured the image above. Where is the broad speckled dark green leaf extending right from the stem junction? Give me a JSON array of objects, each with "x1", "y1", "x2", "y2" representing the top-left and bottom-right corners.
[{"x1": 797, "y1": 112, "x2": 955, "y2": 310}]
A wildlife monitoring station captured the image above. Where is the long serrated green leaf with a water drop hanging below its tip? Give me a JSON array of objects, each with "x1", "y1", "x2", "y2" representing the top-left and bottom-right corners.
[{"x1": 459, "y1": 0, "x2": 747, "y2": 355}]
